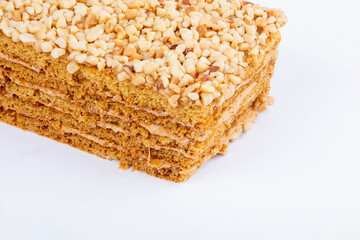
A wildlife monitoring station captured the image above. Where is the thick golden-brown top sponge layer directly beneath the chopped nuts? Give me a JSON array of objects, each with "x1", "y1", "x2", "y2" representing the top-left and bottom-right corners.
[{"x1": 0, "y1": 30, "x2": 281, "y2": 127}]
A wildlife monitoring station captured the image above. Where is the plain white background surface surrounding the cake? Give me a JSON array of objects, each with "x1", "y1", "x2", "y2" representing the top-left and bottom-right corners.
[{"x1": 0, "y1": 0, "x2": 360, "y2": 240}]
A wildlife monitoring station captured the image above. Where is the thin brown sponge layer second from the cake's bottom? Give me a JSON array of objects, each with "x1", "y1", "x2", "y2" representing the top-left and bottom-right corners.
[{"x1": 2, "y1": 69, "x2": 269, "y2": 166}]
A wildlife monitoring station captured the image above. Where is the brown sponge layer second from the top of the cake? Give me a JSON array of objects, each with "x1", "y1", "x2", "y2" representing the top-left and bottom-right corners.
[{"x1": 0, "y1": 40, "x2": 276, "y2": 150}]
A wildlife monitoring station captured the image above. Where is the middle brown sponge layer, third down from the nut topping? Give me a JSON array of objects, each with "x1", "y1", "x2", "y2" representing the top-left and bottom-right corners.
[{"x1": 3, "y1": 60, "x2": 273, "y2": 161}]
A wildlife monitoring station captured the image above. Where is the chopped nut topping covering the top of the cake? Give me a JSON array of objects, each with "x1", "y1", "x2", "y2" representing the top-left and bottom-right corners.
[{"x1": 0, "y1": 0, "x2": 287, "y2": 106}]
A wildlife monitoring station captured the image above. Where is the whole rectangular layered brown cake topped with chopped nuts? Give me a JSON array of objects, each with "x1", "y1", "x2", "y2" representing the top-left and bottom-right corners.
[{"x1": 0, "y1": 0, "x2": 287, "y2": 182}]
